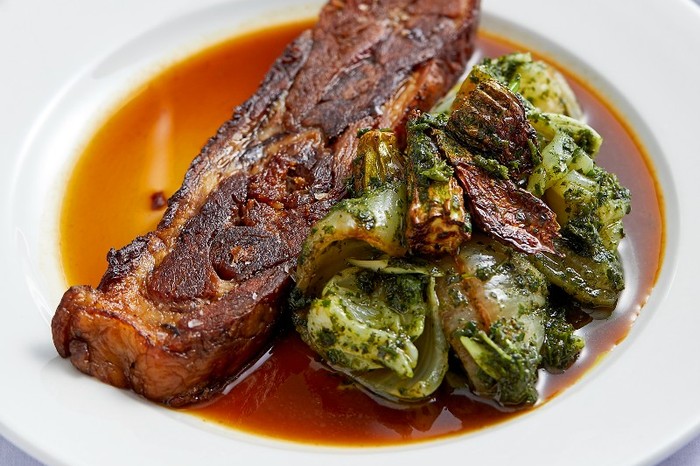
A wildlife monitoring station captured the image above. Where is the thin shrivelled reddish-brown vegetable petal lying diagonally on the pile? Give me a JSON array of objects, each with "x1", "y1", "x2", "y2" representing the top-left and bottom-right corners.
[{"x1": 435, "y1": 129, "x2": 559, "y2": 254}]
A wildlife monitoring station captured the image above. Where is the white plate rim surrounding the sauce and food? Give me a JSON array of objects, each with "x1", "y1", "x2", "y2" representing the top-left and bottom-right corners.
[{"x1": 0, "y1": 0, "x2": 700, "y2": 466}]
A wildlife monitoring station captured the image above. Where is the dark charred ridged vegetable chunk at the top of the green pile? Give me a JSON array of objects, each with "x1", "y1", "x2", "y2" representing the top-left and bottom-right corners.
[{"x1": 447, "y1": 73, "x2": 539, "y2": 183}]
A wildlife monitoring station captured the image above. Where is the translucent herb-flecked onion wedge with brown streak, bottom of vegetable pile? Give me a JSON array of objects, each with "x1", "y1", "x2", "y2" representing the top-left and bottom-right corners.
[{"x1": 437, "y1": 237, "x2": 549, "y2": 405}]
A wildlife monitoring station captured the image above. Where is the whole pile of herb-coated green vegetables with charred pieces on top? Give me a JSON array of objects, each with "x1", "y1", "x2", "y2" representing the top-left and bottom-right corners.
[{"x1": 290, "y1": 53, "x2": 630, "y2": 407}]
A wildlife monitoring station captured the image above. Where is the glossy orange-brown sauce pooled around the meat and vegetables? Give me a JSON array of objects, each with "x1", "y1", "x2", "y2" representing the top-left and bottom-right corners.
[{"x1": 61, "y1": 22, "x2": 663, "y2": 445}]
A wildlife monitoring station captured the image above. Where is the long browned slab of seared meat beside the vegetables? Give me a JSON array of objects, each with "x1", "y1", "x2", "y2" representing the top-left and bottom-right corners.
[{"x1": 52, "y1": 0, "x2": 478, "y2": 406}]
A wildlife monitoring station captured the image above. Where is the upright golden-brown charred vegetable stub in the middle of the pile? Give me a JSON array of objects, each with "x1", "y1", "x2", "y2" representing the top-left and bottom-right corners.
[{"x1": 406, "y1": 115, "x2": 471, "y2": 255}]
